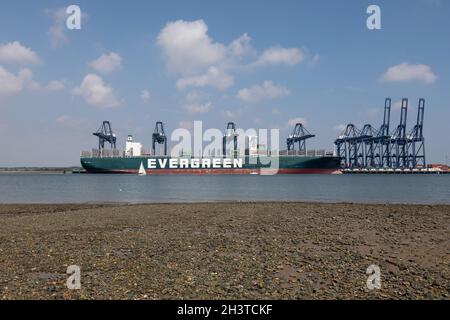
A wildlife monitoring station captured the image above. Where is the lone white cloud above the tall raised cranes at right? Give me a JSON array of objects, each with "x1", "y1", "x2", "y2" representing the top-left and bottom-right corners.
[{"x1": 380, "y1": 62, "x2": 437, "y2": 84}]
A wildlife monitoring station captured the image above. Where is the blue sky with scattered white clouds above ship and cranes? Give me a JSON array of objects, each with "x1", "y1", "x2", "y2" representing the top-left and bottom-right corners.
[{"x1": 0, "y1": 0, "x2": 450, "y2": 167}]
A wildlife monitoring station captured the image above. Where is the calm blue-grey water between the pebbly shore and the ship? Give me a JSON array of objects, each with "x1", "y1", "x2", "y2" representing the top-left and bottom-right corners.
[{"x1": 0, "y1": 174, "x2": 450, "y2": 204}]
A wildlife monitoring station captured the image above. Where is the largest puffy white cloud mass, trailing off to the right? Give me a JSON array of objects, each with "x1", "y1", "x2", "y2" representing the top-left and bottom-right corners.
[{"x1": 156, "y1": 20, "x2": 310, "y2": 94}]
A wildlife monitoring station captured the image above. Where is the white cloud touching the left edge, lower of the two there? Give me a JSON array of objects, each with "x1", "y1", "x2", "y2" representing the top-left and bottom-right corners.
[{"x1": 0, "y1": 66, "x2": 64, "y2": 96}]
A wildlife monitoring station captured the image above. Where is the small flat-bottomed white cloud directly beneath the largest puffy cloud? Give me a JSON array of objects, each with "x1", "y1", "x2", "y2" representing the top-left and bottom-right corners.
[{"x1": 177, "y1": 67, "x2": 234, "y2": 90}]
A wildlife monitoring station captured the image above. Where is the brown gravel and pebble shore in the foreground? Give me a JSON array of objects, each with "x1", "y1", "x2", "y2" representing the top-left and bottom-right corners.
[{"x1": 0, "y1": 202, "x2": 450, "y2": 299}]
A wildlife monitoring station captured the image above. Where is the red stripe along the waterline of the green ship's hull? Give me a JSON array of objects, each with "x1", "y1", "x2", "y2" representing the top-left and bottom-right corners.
[{"x1": 89, "y1": 168, "x2": 340, "y2": 175}]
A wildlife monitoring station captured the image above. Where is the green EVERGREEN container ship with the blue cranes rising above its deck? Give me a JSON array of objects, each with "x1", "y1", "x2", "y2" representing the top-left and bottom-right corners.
[{"x1": 80, "y1": 121, "x2": 341, "y2": 175}]
